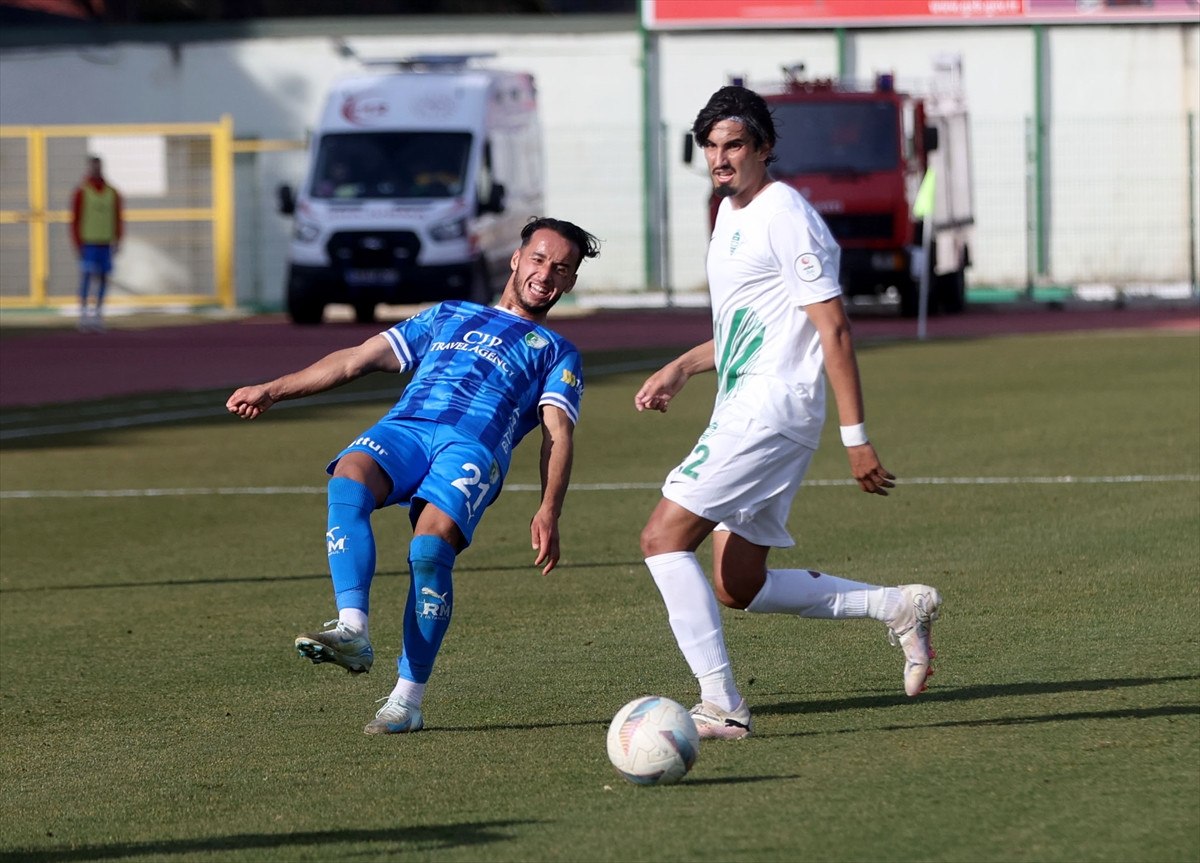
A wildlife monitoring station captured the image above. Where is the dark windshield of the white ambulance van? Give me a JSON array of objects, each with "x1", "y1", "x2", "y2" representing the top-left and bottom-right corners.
[{"x1": 308, "y1": 132, "x2": 470, "y2": 199}]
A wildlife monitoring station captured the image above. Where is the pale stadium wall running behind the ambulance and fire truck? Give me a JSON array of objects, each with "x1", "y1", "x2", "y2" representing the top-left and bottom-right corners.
[{"x1": 0, "y1": 17, "x2": 1200, "y2": 307}]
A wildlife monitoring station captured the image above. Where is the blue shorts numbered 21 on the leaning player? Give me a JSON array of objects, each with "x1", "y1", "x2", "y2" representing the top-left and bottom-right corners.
[{"x1": 325, "y1": 420, "x2": 504, "y2": 545}]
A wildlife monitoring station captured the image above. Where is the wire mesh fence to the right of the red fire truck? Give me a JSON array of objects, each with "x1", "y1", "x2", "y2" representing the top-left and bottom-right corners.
[{"x1": 971, "y1": 115, "x2": 1200, "y2": 293}]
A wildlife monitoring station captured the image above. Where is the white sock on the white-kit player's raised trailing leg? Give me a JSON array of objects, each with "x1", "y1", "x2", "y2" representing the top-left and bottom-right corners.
[{"x1": 746, "y1": 569, "x2": 904, "y2": 621}]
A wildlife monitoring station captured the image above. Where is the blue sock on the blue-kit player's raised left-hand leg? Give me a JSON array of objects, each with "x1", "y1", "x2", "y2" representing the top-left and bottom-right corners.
[{"x1": 325, "y1": 477, "x2": 374, "y2": 615}]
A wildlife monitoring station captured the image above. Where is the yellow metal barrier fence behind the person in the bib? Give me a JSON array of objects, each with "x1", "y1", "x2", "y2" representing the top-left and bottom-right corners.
[{"x1": 0, "y1": 115, "x2": 305, "y2": 310}]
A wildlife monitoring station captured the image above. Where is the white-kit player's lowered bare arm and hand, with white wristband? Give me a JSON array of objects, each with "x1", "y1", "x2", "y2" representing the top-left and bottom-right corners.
[{"x1": 804, "y1": 296, "x2": 895, "y2": 497}]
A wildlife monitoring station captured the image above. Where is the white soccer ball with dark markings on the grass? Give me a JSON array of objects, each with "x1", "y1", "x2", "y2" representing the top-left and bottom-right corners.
[{"x1": 608, "y1": 695, "x2": 700, "y2": 785}]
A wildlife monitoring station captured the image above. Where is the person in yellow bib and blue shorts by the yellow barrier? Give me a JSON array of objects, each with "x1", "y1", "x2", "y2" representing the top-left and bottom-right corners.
[{"x1": 71, "y1": 156, "x2": 122, "y2": 332}]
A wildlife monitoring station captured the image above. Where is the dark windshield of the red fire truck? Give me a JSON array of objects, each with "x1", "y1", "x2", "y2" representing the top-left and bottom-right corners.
[{"x1": 770, "y1": 102, "x2": 900, "y2": 176}]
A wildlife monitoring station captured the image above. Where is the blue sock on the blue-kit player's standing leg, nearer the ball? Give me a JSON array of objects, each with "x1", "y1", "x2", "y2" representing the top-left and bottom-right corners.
[{"x1": 397, "y1": 535, "x2": 455, "y2": 683}]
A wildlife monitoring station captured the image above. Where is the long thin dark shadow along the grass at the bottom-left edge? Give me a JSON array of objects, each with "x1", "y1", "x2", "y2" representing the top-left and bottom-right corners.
[{"x1": 0, "y1": 821, "x2": 540, "y2": 863}]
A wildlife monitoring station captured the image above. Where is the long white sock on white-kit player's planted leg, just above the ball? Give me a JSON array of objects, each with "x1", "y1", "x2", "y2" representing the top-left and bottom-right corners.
[{"x1": 646, "y1": 551, "x2": 742, "y2": 711}]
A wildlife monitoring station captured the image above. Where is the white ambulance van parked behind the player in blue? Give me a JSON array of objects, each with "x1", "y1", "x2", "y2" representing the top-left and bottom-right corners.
[{"x1": 280, "y1": 55, "x2": 542, "y2": 324}]
